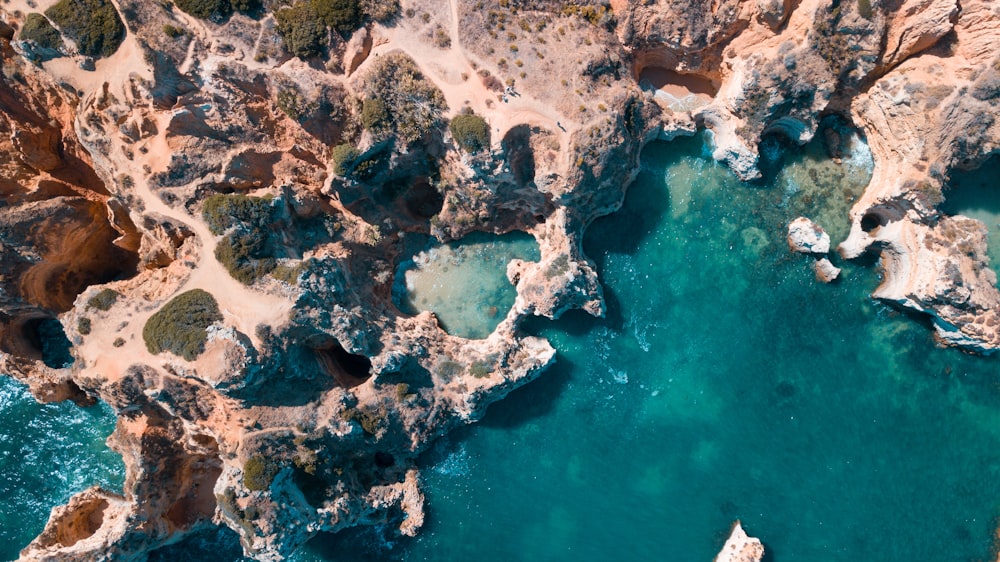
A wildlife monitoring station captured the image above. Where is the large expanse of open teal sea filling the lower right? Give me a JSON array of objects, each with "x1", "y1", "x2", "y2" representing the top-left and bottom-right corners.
[{"x1": 15, "y1": 132, "x2": 1000, "y2": 562}]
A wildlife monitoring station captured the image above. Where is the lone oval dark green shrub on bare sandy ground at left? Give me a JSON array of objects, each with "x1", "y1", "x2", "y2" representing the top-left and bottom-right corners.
[{"x1": 142, "y1": 289, "x2": 222, "y2": 361}]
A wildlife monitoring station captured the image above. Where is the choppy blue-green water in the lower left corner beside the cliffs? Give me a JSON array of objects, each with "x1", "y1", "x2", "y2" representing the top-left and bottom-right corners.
[{"x1": 0, "y1": 376, "x2": 125, "y2": 560}]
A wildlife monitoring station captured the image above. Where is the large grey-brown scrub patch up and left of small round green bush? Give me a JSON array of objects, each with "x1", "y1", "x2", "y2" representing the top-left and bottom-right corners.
[{"x1": 364, "y1": 53, "x2": 447, "y2": 144}]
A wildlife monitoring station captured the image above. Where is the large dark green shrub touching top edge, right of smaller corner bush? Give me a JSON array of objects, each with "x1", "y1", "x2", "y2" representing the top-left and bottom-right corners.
[{"x1": 45, "y1": 0, "x2": 125, "y2": 57}]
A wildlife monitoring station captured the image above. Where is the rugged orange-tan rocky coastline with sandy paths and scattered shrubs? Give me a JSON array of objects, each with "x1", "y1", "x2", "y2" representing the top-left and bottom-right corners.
[{"x1": 0, "y1": 0, "x2": 1000, "y2": 561}]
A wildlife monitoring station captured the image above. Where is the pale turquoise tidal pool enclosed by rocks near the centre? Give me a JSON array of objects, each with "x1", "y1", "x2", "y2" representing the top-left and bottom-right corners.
[{"x1": 394, "y1": 233, "x2": 539, "y2": 339}]
